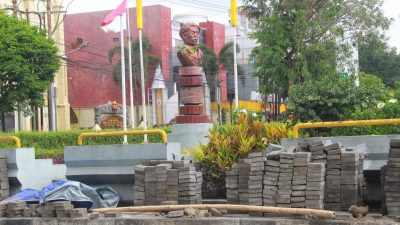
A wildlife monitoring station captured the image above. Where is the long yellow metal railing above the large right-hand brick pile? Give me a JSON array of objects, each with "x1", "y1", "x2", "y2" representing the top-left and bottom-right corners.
[{"x1": 293, "y1": 119, "x2": 400, "y2": 138}]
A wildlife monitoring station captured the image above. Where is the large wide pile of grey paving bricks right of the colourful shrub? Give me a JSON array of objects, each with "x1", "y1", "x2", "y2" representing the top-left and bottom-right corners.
[{"x1": 226, "y1": 141, "x2": 365, "y2": 211}]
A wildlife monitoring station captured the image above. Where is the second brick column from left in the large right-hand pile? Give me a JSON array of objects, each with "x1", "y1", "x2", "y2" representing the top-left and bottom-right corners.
[{"x1": 238, "y1": 159, "x2": 250, "y2": 205}]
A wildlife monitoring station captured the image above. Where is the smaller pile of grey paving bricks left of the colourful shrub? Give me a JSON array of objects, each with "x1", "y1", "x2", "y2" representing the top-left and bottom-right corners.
[{"x1": 133, "y1": 160, "x2": 203, "y2": 205}]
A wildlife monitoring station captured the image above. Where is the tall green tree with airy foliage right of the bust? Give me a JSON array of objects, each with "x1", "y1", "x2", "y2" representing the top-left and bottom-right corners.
[{"x1": 244, "y1": 0, "x2": 390, "y2": 96}]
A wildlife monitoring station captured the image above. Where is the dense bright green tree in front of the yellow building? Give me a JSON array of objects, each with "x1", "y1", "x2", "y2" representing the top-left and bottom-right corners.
[{"x1": 0, "y1": 10, "x2": 60, "y2": 113}]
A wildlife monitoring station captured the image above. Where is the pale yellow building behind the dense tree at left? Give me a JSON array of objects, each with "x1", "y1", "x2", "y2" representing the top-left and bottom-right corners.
[{"x1": 0, "y1": 0, "x2": 70, "y2": 131}]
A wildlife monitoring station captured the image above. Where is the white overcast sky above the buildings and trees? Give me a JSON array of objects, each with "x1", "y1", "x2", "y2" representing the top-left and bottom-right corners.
[{"x1": 64, "y1": 0, "x2": 400, "y2": 52}]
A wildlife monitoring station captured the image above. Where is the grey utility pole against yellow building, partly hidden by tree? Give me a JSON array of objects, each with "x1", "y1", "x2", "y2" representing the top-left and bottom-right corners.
[{"x1": 46, "y1": 0, "x2": 57, "y2": 131}]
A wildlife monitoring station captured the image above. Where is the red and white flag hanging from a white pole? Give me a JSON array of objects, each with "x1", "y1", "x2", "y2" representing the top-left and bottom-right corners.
[{"x1": 101, "y1": 0, "x2": 127, "y2": 33}]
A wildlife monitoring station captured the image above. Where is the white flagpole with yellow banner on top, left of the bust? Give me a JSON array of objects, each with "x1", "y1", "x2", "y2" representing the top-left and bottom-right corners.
[{"x1": 136, "y1": 0, "x2": 148, "y2": 143}]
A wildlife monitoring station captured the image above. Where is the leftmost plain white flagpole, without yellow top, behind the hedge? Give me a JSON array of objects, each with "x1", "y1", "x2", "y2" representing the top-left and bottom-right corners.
[{"x1": 119, "y1": 15, "x2": 128, "y2": 144}]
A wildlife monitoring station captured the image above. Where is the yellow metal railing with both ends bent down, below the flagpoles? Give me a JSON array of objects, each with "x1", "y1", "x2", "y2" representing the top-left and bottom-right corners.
[{"x1": 78, "y1": 129, "x2": 167, "y2": 145}]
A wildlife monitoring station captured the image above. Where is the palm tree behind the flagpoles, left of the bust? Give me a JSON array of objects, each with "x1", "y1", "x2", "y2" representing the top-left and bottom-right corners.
[{"x1": 108, "y1": 37, "x2": 160, "y2": 124}]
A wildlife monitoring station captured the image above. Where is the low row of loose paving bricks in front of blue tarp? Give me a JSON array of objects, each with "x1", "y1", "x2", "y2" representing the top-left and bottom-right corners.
[{"x1": 0, "y1": 201, "x2": 89, "y2": 218}]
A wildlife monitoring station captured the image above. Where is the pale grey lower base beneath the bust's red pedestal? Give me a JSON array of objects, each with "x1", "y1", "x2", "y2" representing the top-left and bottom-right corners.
[{"x1": 168, "y1": 123, "x2": 213, "y2": 150}]
